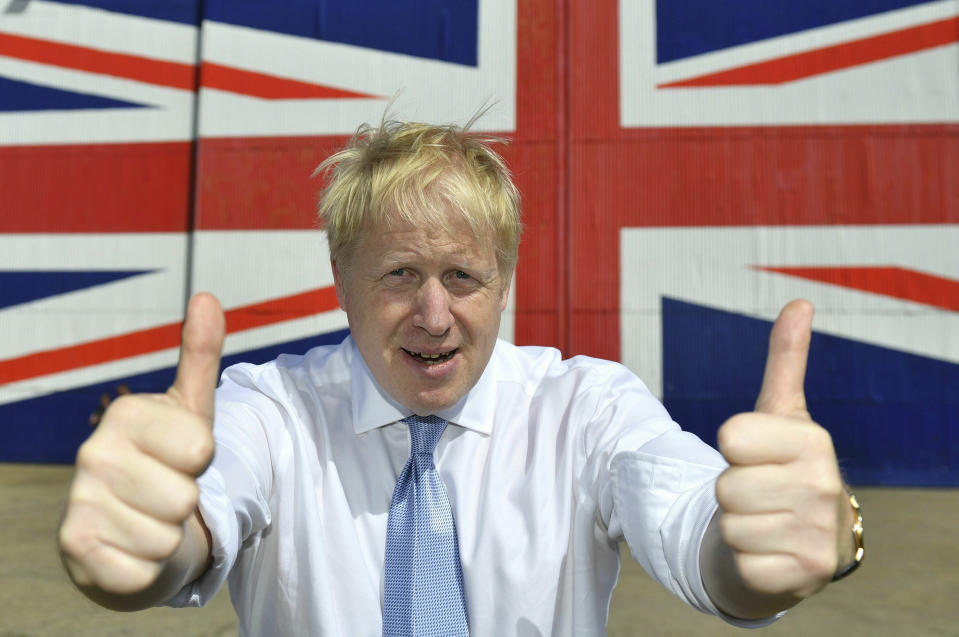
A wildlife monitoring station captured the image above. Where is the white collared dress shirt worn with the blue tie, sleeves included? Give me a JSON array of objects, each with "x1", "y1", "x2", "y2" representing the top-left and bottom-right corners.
[{"x1": 170, "y1": 338, "x2": 766, "y2": 636}]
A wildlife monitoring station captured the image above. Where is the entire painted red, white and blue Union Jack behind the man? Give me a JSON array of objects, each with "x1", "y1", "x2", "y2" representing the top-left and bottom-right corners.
[{"x1": 0, "y1": 0, "x2": 959, "y2": 485}]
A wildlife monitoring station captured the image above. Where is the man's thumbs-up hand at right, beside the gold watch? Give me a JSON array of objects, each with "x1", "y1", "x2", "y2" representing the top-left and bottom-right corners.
[{"x1": 716, "y1": 301, "x2": 852, "y2": 608}]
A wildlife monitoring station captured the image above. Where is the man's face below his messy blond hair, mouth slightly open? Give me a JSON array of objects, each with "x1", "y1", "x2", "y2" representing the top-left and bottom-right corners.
[{"x1": 333, "y1": 212, "x2": 509, "y2": 415}]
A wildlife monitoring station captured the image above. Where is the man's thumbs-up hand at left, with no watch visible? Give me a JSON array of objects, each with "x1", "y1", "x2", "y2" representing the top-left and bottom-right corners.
[{"x1": 59, "y1": 294, "x2": 225, "y2": 610}]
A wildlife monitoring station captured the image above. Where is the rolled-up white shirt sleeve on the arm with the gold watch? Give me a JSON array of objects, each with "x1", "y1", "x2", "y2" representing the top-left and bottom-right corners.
[{"x1": 587, "y1": 362, "x2": 779, "y2": 628}]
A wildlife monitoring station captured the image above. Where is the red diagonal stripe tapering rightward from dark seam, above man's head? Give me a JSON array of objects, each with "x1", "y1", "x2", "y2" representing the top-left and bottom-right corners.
[{"x1": 200, "y1": 62, "x2": 375, "y2": 100}]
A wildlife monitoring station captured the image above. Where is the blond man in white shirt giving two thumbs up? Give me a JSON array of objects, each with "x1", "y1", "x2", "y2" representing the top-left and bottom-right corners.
[{"x1": 60, "y1": 123, "x2": 861, "y2": 635}]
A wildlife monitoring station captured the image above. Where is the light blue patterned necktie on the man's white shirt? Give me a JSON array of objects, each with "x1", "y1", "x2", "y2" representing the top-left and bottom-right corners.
[{"x1": 383, "y1": 416, "x2": 469, "y2": 637}]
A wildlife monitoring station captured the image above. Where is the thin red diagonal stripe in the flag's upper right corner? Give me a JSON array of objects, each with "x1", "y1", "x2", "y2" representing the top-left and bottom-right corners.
[{"x1": 657, "y1": 17, "x2": 959, "y2": 88}]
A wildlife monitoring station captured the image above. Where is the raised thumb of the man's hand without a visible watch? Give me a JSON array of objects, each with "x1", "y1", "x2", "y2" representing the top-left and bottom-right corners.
[{"x1": 168, "y1": 293, "x2": 226, "y2": 421}]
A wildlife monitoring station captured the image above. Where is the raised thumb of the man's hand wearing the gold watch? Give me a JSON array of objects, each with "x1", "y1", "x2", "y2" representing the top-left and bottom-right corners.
[{"x1": 756, "y1": 299, "x2": 814, "y2": 418}]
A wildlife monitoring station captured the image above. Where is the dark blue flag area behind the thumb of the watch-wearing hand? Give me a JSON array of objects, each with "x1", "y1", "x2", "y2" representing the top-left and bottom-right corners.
[{"x1": 662, "y1": 298, "x2": 959, "y2": 486}]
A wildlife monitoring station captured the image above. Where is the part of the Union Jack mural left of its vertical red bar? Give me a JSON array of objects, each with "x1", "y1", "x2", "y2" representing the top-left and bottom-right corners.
[{"x1": 0, "y1": 0, "x2": 516, "y2": 462}]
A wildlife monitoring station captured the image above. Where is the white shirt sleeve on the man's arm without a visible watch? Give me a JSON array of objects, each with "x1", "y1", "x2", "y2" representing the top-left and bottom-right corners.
[{"x1": 166, "y1": 370, "x2": 282, "y2": 607}]
